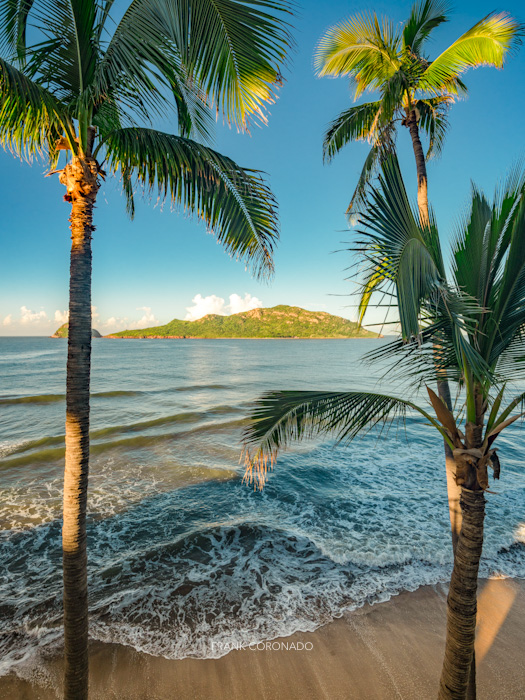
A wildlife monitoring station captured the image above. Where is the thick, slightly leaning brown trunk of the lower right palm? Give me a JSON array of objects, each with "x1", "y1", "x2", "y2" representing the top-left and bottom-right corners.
[{"x1": 438, "y1": 488, "x2": 485, "y2": 700}]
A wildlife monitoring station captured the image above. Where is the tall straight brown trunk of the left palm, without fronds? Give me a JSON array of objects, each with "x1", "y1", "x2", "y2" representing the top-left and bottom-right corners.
[{"x1": 61, "y1": 158, "x2": 98, "y2": 700}]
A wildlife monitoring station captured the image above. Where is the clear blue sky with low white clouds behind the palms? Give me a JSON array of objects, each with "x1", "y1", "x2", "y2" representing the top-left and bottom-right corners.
[{"x1": 0, "y1": 0, "x2": 525, "y2": 335}]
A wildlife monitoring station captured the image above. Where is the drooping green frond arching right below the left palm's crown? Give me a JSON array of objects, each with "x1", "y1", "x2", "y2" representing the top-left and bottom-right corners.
[{"x1": 99, "y1": 128, "x2": 278, "y2": 277}]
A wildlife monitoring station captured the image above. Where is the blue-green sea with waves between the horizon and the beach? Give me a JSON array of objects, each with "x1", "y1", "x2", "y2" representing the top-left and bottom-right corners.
[{"x1": 0, "y1": 338, "x2": 525, "y2": 673}]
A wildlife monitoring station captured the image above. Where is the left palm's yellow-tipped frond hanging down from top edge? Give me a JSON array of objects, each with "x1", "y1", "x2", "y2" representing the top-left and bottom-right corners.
[{"x1": 175, "y1": 0, "x2": 294, "y2": 128}]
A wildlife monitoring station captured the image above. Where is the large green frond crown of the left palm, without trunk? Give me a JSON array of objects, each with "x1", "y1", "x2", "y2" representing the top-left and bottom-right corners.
[{"x1": 0, "y1": 0, "x2": 290, "y2": 274}]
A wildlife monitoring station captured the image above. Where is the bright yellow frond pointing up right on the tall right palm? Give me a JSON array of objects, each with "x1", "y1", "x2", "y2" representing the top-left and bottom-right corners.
[{"x1": 421, "y1": 12, "x2": 523, "y2": 91}]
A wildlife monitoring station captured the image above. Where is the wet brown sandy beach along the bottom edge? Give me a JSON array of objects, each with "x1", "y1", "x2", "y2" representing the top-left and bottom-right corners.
[{"x1": 0, "y1": 579, "x2": 525, "y2": 700}]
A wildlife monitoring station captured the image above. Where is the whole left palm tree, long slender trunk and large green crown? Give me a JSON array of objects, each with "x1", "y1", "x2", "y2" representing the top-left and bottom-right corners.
[{"x1": 0, "y1": 0, "x2": 291, "y2": 698}]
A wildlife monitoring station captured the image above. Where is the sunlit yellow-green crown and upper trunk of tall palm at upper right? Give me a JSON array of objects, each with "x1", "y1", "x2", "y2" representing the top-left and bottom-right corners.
[{"x1": 316, "y1": 0, "x2": 521, "y2": 220}]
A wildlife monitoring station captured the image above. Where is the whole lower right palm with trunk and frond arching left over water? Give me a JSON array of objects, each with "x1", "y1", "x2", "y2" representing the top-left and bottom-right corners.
[{"x1": 245, "y1": 157, "x2": 525, "y2": 699}]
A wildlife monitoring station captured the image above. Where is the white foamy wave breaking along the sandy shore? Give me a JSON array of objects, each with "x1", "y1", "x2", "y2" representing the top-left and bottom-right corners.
[{"x1": 0, "y1": 514, "x2": 525, "y2": 674}]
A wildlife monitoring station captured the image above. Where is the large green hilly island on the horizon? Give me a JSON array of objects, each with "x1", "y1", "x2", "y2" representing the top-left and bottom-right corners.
[{"x1": 106, "y1": 305, "x2": 380, "y2": 338}]
